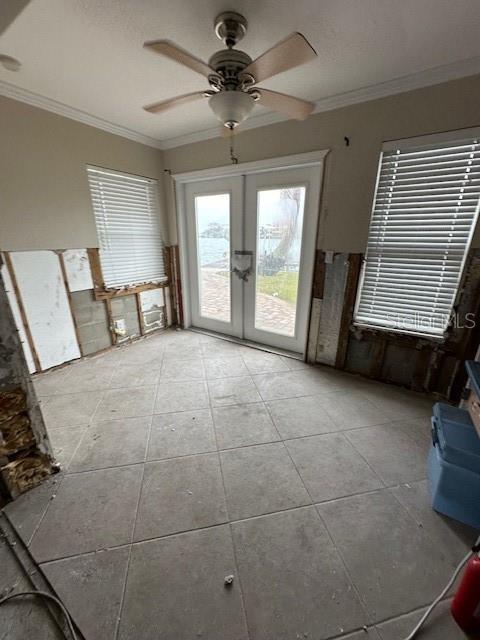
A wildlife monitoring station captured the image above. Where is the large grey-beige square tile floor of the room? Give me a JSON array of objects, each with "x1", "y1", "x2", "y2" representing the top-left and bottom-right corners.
[{"x1": 0, "y1": 331, "x2": 475, "y2": 640}]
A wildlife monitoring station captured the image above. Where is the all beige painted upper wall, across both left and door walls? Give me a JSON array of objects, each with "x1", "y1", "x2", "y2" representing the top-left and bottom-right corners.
[{"x1": 0, "y1": 76, "x2": 480, "y2": 252}]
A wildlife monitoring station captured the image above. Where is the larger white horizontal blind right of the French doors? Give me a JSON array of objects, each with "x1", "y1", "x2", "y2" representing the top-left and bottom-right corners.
[{"x1": 354, "y1": 132, "x2": 480, "y2": 337}]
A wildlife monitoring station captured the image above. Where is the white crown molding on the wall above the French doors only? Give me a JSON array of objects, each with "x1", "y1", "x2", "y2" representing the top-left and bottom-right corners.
[{"x1": 162, "y1": 56, "x2": 480, "y2": 149}]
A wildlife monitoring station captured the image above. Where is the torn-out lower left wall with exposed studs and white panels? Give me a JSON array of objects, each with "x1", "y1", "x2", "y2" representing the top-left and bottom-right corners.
[{"x1": 2, "y1": 249, "x2": 172, "y2": 373}]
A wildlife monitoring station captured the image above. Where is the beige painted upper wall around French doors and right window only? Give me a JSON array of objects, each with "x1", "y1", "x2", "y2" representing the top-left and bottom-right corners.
[{"x1": 164, "y1": 76, "x2": 480, "y2": 252}]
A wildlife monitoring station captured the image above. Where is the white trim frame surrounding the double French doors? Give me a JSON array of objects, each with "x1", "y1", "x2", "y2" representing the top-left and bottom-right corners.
[{"x1": 171, "y1": 149, "x2": 330, "y2": 353}]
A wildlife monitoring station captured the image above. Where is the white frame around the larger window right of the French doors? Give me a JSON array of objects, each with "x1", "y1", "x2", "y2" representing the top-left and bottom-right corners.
[{"x1": 352, "y1": 127, "x2": 480, "y2": 342}]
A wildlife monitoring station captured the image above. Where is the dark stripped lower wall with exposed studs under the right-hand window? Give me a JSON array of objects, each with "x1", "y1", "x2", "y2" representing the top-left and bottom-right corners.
[{"x1": 312, "y1": 249, "x2": 480, "y2": 400}]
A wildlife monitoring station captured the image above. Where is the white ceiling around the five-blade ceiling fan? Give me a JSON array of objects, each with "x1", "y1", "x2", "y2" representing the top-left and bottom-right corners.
[{"x1": 0, "y1": 0, "x2": 480, "y2": 146}]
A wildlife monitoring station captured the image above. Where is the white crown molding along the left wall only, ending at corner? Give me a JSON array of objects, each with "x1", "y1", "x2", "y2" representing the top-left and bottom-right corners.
[{"x1": 0, "y1": 80, "x2": 162, "y2": 149}]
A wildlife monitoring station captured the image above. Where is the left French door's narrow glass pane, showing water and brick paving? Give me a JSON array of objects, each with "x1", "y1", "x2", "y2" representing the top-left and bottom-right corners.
[{"x1": 195, "y1": 193, "x2": 231, "y2": 322}]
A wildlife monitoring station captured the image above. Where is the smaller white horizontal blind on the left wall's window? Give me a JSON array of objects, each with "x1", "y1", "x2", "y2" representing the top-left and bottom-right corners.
[{"x1": 87, "y1": 167, "x2": 166, "y2": 287}]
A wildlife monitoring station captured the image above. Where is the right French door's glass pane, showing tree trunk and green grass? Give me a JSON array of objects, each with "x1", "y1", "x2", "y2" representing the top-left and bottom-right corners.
[{"x1": 255, "y1": 187, "x2": 305, "y2": 336}]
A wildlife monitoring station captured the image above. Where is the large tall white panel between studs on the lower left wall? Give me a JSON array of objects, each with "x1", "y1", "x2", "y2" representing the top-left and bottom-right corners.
[{"x1": 11, "y1": 251, "x2": 80, "y2": 369}]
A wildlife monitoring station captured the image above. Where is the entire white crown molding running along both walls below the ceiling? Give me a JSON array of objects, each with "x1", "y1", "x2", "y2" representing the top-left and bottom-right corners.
[{"x1": 0, "y1": 56, "x2": 480, "y2": 149}]
